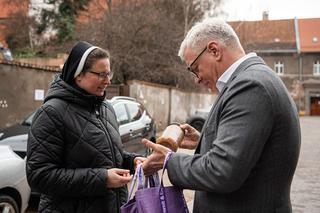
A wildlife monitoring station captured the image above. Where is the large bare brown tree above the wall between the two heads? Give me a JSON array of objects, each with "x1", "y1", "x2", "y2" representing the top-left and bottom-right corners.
[{"x1": 73, "y1": 0, "x2": 224, "y2": 89}]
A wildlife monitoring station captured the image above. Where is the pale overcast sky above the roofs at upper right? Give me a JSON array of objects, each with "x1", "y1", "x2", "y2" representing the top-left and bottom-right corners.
[{"x1": 222, "y1": 0, "x2": 320, "y2": 21}]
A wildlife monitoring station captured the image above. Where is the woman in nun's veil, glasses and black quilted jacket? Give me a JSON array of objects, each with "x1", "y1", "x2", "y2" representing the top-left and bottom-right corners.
[{"x1": 26, "y1": 42, "x2": 144, "y2": 213}]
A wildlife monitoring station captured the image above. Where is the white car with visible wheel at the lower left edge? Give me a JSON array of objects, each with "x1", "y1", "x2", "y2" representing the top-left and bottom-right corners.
[{"x1": 0, "y1": 145, "x2": 30, "y2": 213}]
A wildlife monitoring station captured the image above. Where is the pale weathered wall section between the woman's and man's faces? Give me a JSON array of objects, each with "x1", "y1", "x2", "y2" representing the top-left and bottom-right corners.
[{"x1": 128, "y1": 81, "x2": 216, "y2": 130}]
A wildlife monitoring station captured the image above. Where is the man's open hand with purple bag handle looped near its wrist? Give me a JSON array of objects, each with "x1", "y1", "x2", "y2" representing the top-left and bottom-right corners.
[{"x1": 142, "y1": 139, "x2": 171, "y2": 176}]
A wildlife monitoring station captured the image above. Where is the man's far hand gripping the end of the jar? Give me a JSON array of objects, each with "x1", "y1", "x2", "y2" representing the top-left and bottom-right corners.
[{"x1": 179, "y1": 124, "x2": 200, "y2": 149}]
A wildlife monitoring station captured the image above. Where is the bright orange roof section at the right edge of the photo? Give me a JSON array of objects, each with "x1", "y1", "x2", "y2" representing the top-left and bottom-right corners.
[{"x1": 298, "y1": 18, "x2": 320, "y2": 52}]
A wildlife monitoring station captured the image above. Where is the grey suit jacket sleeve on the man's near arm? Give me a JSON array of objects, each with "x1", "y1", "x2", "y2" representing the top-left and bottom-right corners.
[{"x1": 168, "y1": 80, "x2": 274, "y2": 193}]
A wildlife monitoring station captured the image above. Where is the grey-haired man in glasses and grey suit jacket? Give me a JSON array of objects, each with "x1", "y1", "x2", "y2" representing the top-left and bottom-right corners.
[{"x1": 143, "y1": 18, "x2": 300, "y2": 213}]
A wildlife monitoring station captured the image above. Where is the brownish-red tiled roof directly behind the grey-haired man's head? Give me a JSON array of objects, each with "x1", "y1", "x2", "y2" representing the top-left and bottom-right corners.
[{"x1": 229, "y1": 19, "x2": 297, "y2": 52}]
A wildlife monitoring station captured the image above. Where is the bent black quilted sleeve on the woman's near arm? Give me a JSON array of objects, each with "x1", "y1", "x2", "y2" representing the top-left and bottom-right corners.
[{"x1": 26, "y1": 106, "x2": 108, "y2": 197}]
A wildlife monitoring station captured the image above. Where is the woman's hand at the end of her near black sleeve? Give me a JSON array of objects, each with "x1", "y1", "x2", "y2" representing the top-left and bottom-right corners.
[{"x1": 107, "y1": 168, "x2": 132, "y2": 188}]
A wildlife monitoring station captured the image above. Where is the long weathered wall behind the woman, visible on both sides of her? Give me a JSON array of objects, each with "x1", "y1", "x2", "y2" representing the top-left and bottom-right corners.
[{"x1": 0, "y1": 61, "x2": 215, "y2": 129}]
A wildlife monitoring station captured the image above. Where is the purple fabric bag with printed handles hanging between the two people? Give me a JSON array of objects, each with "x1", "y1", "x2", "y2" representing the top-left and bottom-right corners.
[{"x1": 120, "y1": 152, "x2": 189, "y2": 213}]
